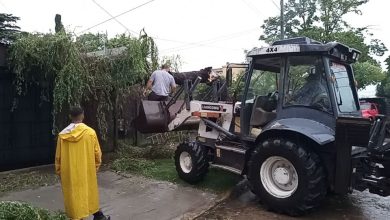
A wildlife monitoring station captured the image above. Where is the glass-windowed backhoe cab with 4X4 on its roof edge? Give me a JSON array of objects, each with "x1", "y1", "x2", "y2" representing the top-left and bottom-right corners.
[{"x1": 236, "y1": 38, "x2": 360, "y2": 138}]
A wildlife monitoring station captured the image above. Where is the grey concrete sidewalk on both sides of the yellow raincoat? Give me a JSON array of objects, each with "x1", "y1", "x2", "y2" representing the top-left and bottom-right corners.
[{"x1": 0, "y1": 171, "x2": 217, "y2": 220}]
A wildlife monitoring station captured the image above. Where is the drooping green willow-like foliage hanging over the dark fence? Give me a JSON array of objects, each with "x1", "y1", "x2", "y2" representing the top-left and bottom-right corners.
[{"x1": 10, "y1": 31, "x2": 158, "y2": 138}]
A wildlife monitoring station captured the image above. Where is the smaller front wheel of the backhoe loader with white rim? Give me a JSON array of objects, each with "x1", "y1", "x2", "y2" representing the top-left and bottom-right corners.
[{"x1": 175, "y1": 142, "x2": 209, "y2": 184}]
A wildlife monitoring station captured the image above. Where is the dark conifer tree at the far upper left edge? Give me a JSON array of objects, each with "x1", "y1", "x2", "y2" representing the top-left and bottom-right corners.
[{"x1": 0, "y1": 13, "x2": 20, "y2": 43}]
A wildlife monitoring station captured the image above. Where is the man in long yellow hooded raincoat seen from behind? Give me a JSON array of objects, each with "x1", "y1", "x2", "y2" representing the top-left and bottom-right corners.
[{"x1": 55, "y1": 107, "x2": 110, "y2": 220}]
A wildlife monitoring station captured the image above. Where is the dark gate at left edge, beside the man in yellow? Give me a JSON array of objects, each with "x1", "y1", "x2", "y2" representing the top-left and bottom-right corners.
[{"x1": 0, "y1": 67, "x2": 55, "y2": 171}]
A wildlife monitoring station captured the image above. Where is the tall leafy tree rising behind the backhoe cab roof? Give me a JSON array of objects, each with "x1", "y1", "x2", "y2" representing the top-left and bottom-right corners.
[{"x1": 260, "y1": 0, "x2": 387, "y2": 89}]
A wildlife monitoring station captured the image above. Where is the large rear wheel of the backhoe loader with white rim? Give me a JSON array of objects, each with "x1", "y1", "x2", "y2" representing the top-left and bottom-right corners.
[{"x1": 248, "y1": 138, "x2": 327, "y2": 216}]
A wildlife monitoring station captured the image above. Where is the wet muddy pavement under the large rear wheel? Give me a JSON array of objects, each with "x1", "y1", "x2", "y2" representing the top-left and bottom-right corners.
[{"x1": 197, "y1": 180, "x2": 390, "y2": 220}]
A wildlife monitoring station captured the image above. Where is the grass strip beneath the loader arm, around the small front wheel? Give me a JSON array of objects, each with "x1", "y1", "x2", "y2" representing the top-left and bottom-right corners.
[{"x1": 111, "y1": 158, "x2": 239, "y2": 192}]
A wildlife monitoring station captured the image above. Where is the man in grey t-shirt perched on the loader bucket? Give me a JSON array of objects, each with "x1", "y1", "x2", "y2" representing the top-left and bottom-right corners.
[{"x1": 146, "y1": 64, "x2": 176, "y2": 101}]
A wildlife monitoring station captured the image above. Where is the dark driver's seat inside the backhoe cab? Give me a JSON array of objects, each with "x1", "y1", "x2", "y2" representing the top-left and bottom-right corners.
[{"x1": 250, "y1": 96, "x2": 276, "y2": 127}]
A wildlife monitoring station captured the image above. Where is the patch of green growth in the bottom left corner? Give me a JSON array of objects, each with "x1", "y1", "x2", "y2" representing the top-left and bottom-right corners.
[{"x1": 0, "y1": 201, "x2": 68, "y2": 220}]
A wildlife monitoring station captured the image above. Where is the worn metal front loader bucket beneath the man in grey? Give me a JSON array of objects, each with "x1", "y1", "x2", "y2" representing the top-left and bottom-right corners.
[{"x1": 135, "y1": 100, "x2": 170, "y2": 133}]
